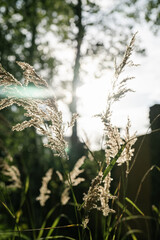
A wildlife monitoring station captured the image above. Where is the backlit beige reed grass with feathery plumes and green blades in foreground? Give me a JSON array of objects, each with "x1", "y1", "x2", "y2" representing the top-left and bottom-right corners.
[{"x1": 0, "y1": 34, "x2": 160, "y2": 240}]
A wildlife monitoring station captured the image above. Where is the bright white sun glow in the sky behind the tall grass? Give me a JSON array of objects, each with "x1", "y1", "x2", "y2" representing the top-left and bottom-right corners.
[{"x1": 46, "y1": 24, "x2": 160, "y2": 149}]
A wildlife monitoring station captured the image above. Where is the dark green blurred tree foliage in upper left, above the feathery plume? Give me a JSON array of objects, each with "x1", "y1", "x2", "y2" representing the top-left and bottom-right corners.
[{"x1": 0, "y1": 0, "x2": 71, "y2": 81}]
